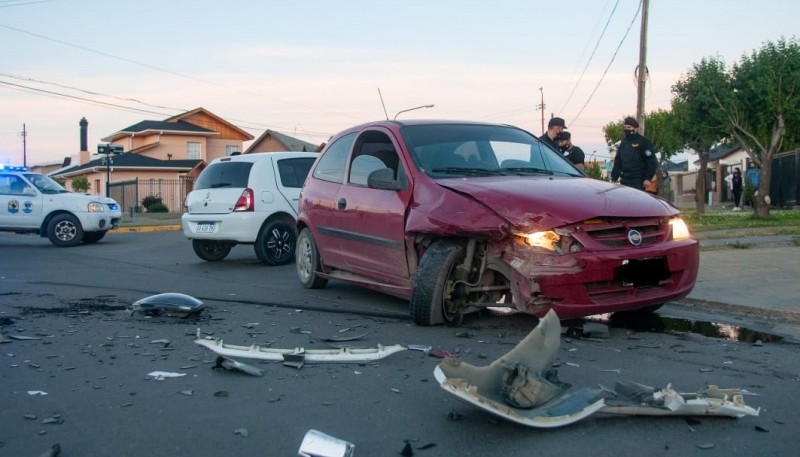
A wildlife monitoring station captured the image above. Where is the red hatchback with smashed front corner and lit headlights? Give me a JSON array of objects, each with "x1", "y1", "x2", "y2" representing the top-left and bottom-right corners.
[{"x1": 296, "y1": 120, "x2": 699, "y2": 325}]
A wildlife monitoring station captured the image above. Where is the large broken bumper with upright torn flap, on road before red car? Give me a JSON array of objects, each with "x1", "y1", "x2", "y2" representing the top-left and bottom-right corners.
[{"x1": 434, "y1": 311, "x2": 759, "y2": 428}]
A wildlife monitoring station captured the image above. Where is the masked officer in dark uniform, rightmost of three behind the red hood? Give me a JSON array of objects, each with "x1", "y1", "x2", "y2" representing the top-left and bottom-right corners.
[{"x1": 611, "y1": 117, "x2": 658, "y2": 190}]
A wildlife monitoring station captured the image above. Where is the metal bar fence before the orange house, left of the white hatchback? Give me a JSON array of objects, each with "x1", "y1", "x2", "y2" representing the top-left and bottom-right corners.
[{"x1": 109, "y1": 177, "x2": 194, "y2": 213}]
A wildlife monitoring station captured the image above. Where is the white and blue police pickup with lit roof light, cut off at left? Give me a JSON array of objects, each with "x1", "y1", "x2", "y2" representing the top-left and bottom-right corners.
[{"x1": 0, "y1": 164, "x2": 122, "y2": 247}]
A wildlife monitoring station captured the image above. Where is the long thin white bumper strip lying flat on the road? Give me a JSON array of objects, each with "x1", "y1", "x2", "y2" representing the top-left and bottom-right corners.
[{"x1": 194, "y1": 338, "x2": 406, "y2": 363}]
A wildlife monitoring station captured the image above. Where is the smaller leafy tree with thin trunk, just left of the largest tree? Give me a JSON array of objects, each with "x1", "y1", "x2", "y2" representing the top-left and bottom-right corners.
[{"x1": 672, "y1": 58, "x2": 732, "y2": 214}]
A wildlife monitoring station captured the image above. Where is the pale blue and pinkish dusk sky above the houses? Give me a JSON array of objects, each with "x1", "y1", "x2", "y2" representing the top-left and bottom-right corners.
[{"x1": 0, "y1": 0, "x2": 800, "y2": 165}]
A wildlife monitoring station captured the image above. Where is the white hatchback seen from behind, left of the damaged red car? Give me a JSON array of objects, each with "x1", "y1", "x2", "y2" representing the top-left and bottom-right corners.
[{"x1": 181, "y1": 152, "x2": 319, "y2": 265}]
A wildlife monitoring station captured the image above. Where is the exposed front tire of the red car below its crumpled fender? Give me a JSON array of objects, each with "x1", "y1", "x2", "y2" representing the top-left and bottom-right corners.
[{"x1": 410, "y1": 240, "x2": 465, "y2": 326}]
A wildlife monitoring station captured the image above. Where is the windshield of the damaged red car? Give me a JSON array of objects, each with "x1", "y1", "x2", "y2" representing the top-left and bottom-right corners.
[{"x1": 402, "y1": 124, "x2": 584, "y2": 179}]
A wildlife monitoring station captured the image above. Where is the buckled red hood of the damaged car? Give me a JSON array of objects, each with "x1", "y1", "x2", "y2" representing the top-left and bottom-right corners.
[{"x1": 437, "y1": 176, "x2": 679, "y2": 228}]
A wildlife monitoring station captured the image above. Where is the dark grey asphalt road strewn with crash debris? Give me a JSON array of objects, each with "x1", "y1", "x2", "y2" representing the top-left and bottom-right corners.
[{"x1": 0, "y1": 232, "x2": 800, "y2": 457}]
